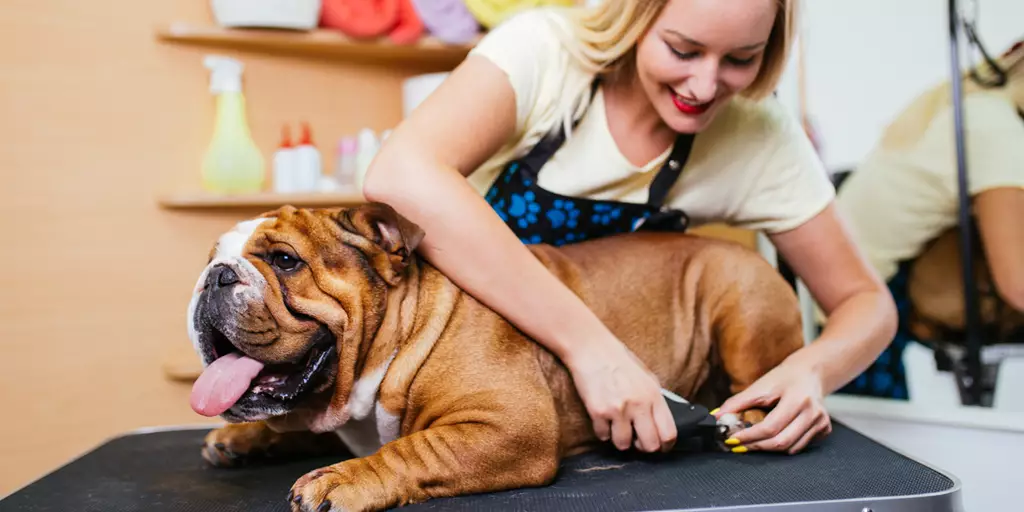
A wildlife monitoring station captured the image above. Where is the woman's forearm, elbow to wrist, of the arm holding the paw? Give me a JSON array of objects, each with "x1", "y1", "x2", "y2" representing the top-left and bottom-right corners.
[{"x1": 785, "y1": 290, "x2": 897, "y2": 394}]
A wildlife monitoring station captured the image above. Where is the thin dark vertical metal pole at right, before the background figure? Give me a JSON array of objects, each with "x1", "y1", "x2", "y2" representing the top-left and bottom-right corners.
[{"x1": 949, "y1": 0, "x2": 982, "y2": 406}]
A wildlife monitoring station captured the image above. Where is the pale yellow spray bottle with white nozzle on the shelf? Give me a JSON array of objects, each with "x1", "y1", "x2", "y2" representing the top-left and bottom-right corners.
[{"x1": 202, "y1": 55, "x2": 266, "y2": 194}]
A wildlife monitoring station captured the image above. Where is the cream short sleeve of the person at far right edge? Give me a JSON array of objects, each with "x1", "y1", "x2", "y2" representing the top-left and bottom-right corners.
[{"x1": 918, "y1": 93, "x2": 1024, "y2": 195}]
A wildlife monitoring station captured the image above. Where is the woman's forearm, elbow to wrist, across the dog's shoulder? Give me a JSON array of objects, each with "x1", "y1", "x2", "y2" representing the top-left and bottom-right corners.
[{"x1": 368, "y1": 158, "x2": 614, "y2": 362}]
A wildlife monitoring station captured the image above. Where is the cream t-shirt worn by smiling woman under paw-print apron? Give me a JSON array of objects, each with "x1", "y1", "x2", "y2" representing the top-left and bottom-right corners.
[{"x1": 469, "y1": 7, "x2": 835, "y2": 232}]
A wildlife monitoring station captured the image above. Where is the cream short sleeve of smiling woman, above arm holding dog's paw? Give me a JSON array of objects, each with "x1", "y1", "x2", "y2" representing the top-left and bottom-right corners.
[{"x1": 734, "y1": 108, "x2": 836, "y2": 233}]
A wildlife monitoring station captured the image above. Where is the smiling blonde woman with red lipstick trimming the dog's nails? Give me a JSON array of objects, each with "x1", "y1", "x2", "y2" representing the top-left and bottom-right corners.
[{"x1": 364, "y1": 0, "x2": 894, "y2": 452}]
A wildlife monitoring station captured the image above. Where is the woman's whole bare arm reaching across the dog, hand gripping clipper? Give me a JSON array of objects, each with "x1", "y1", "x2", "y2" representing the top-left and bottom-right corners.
[{"x1": 364, "y1": 55, "x2": 676, "y2": 452}]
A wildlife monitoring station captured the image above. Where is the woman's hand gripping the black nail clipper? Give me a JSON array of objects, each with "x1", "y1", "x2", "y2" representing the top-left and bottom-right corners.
[{"x1": 565, "y1": 339, "x2": 677, "y2": 453}]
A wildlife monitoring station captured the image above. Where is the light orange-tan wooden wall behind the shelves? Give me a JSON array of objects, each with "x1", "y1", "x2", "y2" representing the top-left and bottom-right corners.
[{"x1": 0, "y1": 0, "x2": 752, "y2": 496}]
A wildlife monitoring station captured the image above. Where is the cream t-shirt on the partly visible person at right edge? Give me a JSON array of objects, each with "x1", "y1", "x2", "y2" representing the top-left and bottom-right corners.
[{"x1": 837, "y1": 85, "x2": 1024, "y2": 281}]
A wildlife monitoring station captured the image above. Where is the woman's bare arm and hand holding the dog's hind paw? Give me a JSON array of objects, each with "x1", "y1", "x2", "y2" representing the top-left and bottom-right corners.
[{"x1": 721, "y1": 205, "x2": 897, "y2": 453}]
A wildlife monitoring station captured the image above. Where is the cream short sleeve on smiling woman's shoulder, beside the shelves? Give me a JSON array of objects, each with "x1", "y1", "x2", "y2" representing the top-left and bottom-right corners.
[{"x1": 470, "y1": 8, "x2": 564, "y2": 130}]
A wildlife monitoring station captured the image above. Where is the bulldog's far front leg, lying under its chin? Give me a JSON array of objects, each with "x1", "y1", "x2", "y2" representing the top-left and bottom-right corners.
[{"x1": 202, "y1": 422, "x2": 351, "y2": 467}]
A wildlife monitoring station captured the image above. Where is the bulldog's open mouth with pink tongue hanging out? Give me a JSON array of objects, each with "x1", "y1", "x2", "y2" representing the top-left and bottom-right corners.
[{"x1": 190, "y1": 329, "x2": 337, "y2": 417}]
